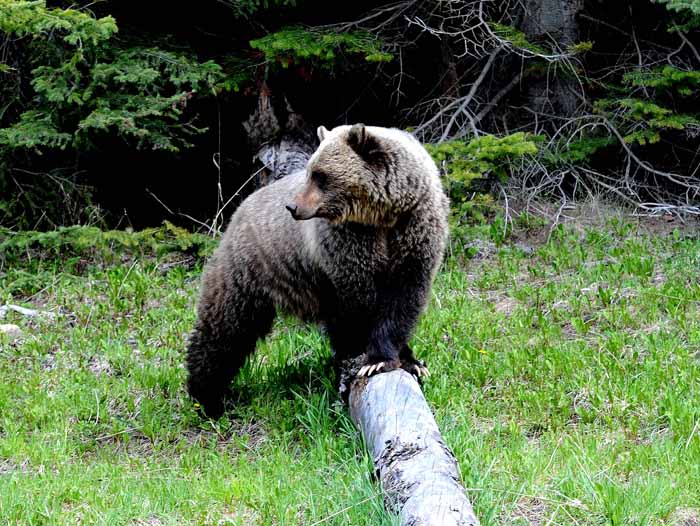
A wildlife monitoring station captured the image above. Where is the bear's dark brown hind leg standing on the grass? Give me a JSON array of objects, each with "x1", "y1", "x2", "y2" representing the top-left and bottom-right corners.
[{"x1": 187, "y1": 283, "x2": 275, "y2": 418}]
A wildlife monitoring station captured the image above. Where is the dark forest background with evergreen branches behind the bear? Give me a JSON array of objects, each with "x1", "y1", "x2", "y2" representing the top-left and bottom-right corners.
[{"x1": 0, "y1": 0, "x2": 700, "y2": 230}]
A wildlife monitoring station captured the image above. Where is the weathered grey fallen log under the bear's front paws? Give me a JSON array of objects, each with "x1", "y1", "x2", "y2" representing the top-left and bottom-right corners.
[{"x1": 349, "y1": 369, "x2": 479, "y2": 526}]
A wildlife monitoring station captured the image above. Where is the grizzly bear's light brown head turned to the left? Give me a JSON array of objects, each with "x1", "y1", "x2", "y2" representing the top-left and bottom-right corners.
[{"x1": 287, "y1": 124, "x2": 440, "y2": 226}]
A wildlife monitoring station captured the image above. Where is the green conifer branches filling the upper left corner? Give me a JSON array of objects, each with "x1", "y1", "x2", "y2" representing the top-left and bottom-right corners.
[{"x1": 0, "y1": 0, "x2": 228, "y2": 151}]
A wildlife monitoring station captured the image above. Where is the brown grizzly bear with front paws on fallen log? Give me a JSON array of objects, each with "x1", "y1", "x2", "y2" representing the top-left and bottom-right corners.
[{"x1": 187, "y1": 124, "x2": 449, "y2": 417}]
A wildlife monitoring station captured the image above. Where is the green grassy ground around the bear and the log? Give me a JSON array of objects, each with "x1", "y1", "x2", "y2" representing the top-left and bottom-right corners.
[{"x1": 0, "y1": 216, "x2": 700, "y2": 525}]
